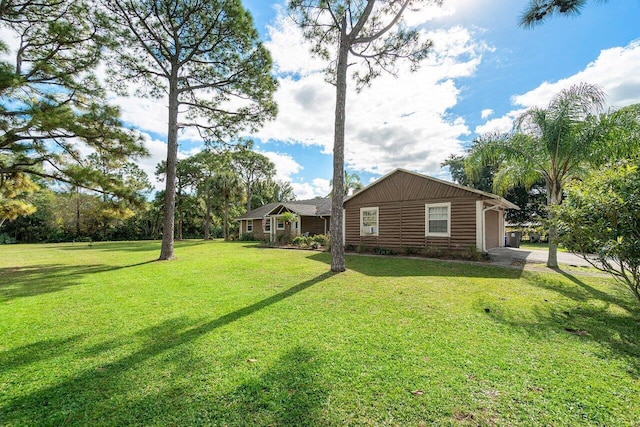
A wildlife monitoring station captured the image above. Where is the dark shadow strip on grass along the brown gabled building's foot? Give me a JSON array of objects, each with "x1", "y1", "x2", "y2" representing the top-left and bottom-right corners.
[{"x1": 308, "y1": 252, "x2": 522, "y2": 279}]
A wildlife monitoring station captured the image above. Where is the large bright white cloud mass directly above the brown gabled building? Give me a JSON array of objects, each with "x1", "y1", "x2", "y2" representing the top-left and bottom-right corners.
[{"x1": 252, "y1": 18, "x2": 490, "y2": 179}]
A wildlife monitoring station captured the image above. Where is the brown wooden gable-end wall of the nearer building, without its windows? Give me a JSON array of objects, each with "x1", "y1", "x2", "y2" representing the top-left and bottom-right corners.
[{"x1": 344, "y1": 171, "x2": 482, "y2": 251}]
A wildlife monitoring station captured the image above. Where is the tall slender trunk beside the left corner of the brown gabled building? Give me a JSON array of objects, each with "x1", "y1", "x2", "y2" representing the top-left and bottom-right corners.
[{"x1": 331, "y1": 18, "x2": 349, "y2": 273}]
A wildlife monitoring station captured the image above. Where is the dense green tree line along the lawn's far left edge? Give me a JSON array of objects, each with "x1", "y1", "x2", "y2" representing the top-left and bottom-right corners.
[{"x1": 0, "y1": 148, "x2": 295, "y2": 243}]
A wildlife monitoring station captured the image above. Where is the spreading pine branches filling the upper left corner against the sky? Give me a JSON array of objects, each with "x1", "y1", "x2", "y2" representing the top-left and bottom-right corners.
[{"x1": 0, "y1": 0, "x2": 145, "y2": 214}]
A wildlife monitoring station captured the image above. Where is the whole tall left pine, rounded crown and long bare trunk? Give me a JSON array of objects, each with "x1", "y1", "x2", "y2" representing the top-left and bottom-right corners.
[{"x1": 102, "y1": 0, "x2": 276, "y2": 260}]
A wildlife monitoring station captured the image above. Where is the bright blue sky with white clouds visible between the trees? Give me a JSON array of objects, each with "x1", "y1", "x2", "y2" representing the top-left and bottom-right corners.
[{"x1": 111, "y1": 0, "x2": 640, "y2": 199}]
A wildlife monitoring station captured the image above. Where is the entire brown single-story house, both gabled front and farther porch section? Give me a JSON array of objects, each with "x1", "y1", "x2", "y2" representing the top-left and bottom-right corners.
[{"x1": 238, "y1": 169, "x2": 519, "y2": 252}]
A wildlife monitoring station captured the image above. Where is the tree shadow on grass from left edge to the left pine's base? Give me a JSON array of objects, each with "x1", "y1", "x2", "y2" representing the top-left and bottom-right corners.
[{"x1": 0, "y1": 260, "x2": 156, "y2": 302}]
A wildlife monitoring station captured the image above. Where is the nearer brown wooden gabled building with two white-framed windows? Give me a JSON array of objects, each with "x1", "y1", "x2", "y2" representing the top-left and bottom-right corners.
[{"x1": 343, "y1": 169, "x2": 519, "y2": 252}]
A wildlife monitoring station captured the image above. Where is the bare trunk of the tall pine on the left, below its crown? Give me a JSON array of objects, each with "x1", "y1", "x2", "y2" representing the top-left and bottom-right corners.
[{"x1": 160, "y1": 66, "x2": 178, "y2": 260}]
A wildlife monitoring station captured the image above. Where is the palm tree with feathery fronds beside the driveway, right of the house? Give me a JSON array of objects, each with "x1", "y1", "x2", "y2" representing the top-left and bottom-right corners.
[{"x1": 469, "y1": 83, "x2": 605, "y2": 267}]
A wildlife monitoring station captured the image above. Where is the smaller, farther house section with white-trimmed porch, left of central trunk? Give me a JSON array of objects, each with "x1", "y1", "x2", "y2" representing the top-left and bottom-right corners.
[{"x1": 237, "y1": 199, "x2": 331, "y2": 242}]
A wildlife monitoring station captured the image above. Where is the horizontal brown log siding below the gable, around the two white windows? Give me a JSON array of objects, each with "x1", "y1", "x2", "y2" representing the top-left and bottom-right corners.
[{"x1": 345, "y1": 199, "x2": 477, "y2": 251}]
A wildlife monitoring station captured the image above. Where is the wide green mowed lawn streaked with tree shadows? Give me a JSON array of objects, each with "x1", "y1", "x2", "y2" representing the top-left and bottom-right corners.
[{"x1": 0, "y1": 241, "x2": 640, "y2": 426}]
